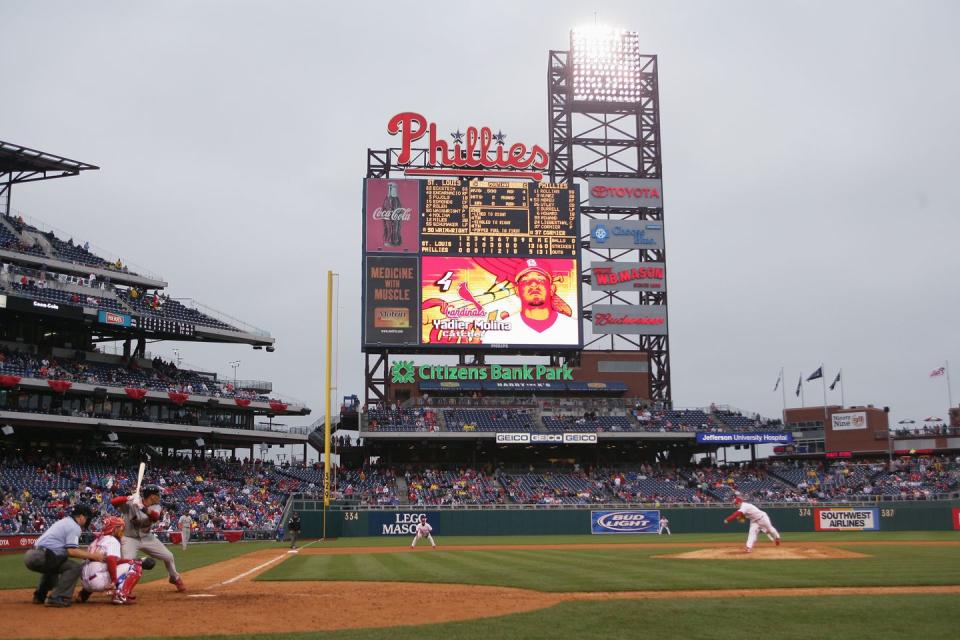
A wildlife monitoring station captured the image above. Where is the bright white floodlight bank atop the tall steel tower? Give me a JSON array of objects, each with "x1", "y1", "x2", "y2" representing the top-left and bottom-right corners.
[{"x1": 570, "y1": 26, "x2": 642, "y2": 103}]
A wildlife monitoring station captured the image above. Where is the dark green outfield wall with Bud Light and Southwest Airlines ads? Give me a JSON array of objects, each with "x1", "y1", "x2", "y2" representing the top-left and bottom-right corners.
[{"x1": 293, "y1": 499, "x2": 960, "y2": 538}]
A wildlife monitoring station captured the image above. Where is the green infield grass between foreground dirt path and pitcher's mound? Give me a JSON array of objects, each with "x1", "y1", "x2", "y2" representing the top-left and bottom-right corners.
[{"x1": 257, "y1": 534, "x2": 960, "y2": 592}]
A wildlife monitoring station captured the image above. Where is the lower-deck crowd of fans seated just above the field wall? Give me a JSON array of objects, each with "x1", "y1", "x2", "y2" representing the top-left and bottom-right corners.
[{"x1": 0, "y1": 451, "x2": 960, "y2": 539}]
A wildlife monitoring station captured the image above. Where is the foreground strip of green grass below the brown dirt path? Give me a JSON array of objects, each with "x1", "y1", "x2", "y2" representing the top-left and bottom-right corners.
[{"x1": 133, "y1": 595, "x2": 960, "y2": 640}]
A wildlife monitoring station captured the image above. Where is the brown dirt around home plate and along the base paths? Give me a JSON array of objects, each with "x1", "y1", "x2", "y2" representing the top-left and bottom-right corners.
[{"x1": 7, "y1": 544, "x2": 960, "y2": 639}]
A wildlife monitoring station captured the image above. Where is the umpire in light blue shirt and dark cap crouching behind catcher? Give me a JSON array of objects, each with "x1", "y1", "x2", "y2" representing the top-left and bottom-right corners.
[{"x1": 23, "y1": 504, "x2": 105, "y2": 607}]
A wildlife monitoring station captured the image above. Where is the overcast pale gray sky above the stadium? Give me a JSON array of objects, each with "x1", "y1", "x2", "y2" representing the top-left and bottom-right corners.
[{"x1": 0, "y1": 0, "x2": 960, "y2": 430}]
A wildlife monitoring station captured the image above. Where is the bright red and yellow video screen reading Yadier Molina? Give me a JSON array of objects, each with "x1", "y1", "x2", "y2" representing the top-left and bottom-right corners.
[{"x1": 421, "y1": 257, "x2": 580, "y2": 348}]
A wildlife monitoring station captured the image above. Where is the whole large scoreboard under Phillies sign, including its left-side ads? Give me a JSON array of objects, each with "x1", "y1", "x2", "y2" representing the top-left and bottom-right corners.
[{"x1": 362, "y1": 178, "x2": 583, "y2": 351}]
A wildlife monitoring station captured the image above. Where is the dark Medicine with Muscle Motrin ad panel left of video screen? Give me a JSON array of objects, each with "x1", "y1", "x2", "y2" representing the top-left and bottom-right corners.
[{"x1": 363, "y1": 256, "x2": 420, "y2": 346}]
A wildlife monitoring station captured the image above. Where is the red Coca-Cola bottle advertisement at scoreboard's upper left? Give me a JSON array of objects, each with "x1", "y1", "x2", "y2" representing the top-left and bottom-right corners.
[{"x1": 364, "y1": 178, "x2": 420, "y2": 254}]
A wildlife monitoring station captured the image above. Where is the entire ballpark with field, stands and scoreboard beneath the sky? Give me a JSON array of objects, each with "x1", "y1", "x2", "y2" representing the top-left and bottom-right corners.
[{"x1": 0, "y1": 17, "x2": 960, "y2": 640}]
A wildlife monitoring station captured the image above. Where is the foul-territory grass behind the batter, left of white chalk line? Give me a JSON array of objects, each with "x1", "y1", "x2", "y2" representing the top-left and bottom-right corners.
[{"x1": 0, "y1": 542, "x2": 290, "y2": 589}]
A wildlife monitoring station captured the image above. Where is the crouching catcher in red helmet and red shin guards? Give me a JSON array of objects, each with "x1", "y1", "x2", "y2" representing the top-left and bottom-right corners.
[{"x1": 77, "y1": 516, "x2": 157, "y2": 604}]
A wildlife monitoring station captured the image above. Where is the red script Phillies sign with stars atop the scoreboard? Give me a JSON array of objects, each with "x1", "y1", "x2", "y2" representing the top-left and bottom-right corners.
[{"x1": 387, "y1": 111, "x2": 550, "y2": 180}]
